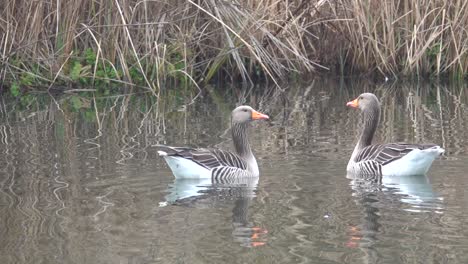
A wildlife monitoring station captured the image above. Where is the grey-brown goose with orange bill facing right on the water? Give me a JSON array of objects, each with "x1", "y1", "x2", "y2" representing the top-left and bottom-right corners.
[{"x1": 156, "y1": 105, "x2": 269, "y2": 181}]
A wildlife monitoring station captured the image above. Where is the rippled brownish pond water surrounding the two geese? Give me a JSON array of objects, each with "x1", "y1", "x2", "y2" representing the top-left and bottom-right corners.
[{"x1": 0, "y1": 80, "x2": 468, "y2": 264}]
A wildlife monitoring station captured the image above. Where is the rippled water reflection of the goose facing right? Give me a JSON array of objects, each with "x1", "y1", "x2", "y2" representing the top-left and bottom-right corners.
[{"x1": 160, "y1": 177, "x2": 268, "y2": 247}]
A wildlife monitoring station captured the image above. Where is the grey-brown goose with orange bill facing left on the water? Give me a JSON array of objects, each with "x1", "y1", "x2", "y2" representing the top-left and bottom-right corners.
[{"x1": 346, "y1": 93, "x2": 444, "y2": 176}]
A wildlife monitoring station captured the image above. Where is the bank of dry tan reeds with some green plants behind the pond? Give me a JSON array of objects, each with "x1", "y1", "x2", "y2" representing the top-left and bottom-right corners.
[{"x1": 0, "y1": 0, "x2": 468, "y2": 96}]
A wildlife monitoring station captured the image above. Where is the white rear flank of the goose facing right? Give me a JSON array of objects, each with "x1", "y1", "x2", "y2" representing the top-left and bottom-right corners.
[{"x1": 162, "y1": 157, "x2": 211, "y2": 179}]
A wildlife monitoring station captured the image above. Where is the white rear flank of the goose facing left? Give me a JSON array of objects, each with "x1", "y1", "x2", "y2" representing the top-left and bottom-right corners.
[{"x1": 382, "y1": 146, "x2": 444, "y2": 176}]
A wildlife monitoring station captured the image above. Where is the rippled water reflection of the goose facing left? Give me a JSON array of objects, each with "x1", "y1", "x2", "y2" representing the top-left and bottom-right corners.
[{"x1": 346, "y1": 174, "x2": 443, "y2": 263}]
